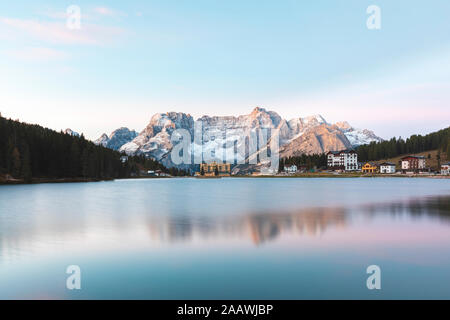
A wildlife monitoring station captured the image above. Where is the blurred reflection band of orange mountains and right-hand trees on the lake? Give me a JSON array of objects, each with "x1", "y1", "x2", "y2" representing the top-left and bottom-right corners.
[{"x1": 148, "y1": 196, "x2": 450, "y2": 245}]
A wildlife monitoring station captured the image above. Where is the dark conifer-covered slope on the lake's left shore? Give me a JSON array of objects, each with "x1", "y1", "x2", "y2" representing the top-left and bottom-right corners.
[{"x1": 0, "y1": 117, "x2": 184, "y2": 182}]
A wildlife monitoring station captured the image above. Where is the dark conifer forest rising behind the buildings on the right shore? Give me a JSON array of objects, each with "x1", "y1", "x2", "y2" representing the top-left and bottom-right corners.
[{"x1": 356, "y1": 127, "x2": 450, "y2": 161}]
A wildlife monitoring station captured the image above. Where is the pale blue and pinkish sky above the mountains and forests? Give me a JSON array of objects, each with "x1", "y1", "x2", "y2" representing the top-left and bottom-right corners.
[{"x1": 0, "y1": 0, "x2": 450, "y2": 138}]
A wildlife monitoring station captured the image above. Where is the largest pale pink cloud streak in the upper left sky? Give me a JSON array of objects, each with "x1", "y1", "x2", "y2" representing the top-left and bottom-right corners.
[{"x1": 0, "y1": 17, "x2": 125, "y2": 45}]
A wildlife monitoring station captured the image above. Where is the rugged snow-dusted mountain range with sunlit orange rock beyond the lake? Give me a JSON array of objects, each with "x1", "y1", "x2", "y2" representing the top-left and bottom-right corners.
[{"x1": 95, "y1": 107, "x2": 382, "y2": 171}]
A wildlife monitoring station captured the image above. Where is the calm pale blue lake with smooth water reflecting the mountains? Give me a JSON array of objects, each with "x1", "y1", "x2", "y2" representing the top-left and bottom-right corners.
[{"x1": 0, "y1": 178, "x2": 450, "y2": 299}]
